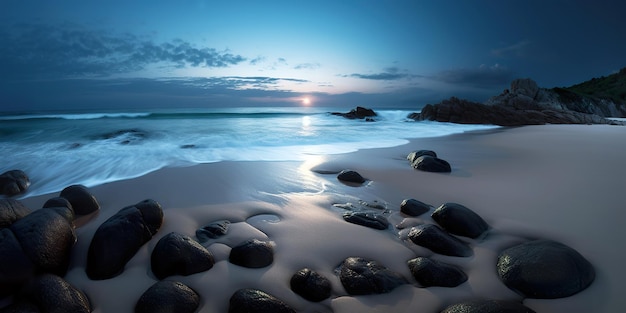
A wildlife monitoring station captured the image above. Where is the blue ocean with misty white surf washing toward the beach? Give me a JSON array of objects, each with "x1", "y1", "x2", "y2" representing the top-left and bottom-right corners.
[{"x1": 0, "y1": 107, "x2": 496, "y2": 197}]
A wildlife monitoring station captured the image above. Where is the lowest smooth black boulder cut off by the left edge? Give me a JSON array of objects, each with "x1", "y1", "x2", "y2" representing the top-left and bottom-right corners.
[{"x1": 0, "y1": 228, "x2": 36, "y2": 299}]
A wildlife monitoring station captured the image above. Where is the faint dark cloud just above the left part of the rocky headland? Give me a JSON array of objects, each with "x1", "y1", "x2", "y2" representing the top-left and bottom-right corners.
[{"x1": 433, "y1": 64, "x2": 514, "y2": 87}]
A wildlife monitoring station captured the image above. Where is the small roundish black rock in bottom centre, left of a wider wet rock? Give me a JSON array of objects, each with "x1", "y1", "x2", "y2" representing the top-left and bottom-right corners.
[{"x1": 290, "y1": 268, "x2": 332, "y2": 302}]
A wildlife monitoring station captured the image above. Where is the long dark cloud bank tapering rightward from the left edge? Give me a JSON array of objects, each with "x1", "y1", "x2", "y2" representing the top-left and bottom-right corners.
[{"x1": 0, "y1": 24, "x2": 246, "y2": 78}]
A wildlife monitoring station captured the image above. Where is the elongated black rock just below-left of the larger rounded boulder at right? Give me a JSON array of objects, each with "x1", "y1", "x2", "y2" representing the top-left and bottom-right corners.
[{"x1": 408, "y1": 224, "x2": 472, "y2": 257}]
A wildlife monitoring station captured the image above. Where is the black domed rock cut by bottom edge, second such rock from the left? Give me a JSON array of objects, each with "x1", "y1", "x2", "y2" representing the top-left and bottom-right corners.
[{"x1": 135, "y1": 280, "x2": 200, "y2": 313}]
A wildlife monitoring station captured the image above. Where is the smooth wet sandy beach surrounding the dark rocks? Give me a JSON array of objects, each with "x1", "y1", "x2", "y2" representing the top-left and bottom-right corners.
[{"x1": 22, "y1": 125, "x2": 626, "y2": 313}]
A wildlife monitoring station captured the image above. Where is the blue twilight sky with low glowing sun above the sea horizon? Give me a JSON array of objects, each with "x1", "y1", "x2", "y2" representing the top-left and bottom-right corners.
[{"x1": 0, "y1": 0, "x2": 626, "y2": 112}]
